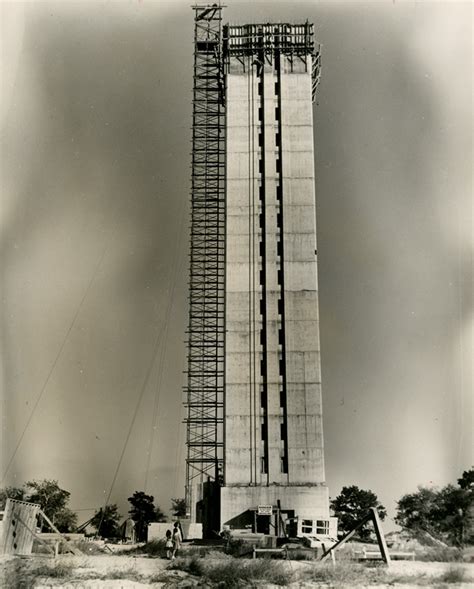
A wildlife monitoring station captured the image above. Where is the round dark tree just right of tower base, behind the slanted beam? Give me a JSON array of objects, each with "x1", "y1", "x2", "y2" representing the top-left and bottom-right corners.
[{"x1": 331, "y1": 485, "x2": 387, "y2": 541}]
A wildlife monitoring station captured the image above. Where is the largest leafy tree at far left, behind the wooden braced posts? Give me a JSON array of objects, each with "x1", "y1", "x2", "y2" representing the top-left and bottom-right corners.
[{"x1": 24, "y1": 479, "x2": 73, "y2": 531}]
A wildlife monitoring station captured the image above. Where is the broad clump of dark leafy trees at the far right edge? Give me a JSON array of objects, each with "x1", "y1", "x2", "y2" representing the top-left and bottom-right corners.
[{"x1": 395, "y1": 469, "x2": 474, "y2": 546}]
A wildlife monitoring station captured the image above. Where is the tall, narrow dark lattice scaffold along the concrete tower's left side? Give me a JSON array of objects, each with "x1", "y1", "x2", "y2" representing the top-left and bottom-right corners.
[{"x1": 185, "y1": 5, "x2": 225, "y2": 509}]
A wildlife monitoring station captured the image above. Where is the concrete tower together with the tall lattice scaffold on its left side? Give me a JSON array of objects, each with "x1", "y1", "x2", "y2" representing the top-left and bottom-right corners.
[{"x1": 187, "y1": 5, "x2": 329, "y2": 534}]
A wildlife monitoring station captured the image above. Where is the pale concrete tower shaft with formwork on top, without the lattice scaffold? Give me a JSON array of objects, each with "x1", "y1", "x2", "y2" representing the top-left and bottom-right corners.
[{"x1": 221, "y1": 23, "x2": 329, "y2": 527}]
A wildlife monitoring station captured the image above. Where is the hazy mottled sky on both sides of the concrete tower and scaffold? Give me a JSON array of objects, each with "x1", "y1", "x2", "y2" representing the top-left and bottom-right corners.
[{"x1": 0, "y1": 0, "x2": 473, "y2": 521}]
